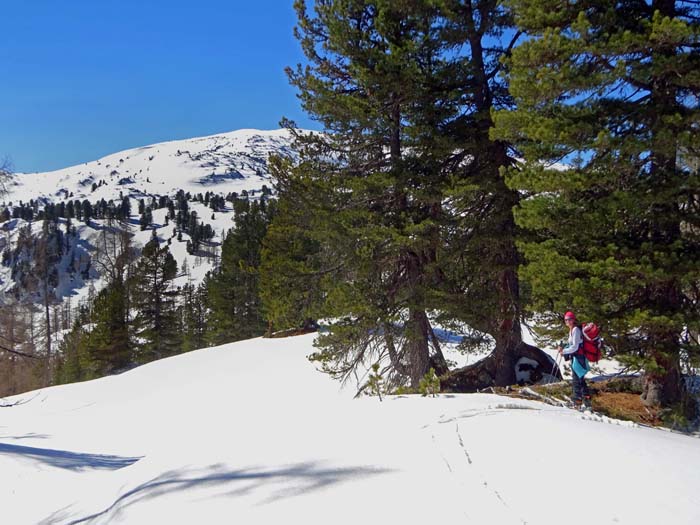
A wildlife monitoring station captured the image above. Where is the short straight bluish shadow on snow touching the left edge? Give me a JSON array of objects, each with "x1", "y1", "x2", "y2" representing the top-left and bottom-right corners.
[{"x1": 0, "y1": 443, "x2": 141, "y2": 471}]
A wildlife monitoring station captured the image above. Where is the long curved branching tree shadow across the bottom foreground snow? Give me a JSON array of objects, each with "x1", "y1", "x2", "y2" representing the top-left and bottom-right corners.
[{"x1": 50, "y1": 463, "x2": 390, "y2": 525}]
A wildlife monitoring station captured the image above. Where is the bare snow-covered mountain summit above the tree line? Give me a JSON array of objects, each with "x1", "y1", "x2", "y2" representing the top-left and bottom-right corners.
[{"x1": 5, "y1": 129, "x2": 292, "y2": 202}]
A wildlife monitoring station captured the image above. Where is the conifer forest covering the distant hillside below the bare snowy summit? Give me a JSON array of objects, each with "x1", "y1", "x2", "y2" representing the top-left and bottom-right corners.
[{"x1": 0, "y1": 188, "x2": 275, "y2": 395}]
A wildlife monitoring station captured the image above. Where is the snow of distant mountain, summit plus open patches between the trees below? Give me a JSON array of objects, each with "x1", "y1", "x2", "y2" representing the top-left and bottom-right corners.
[{"x1": 0, "y1": 129, "x2": 294, "y2": 306}]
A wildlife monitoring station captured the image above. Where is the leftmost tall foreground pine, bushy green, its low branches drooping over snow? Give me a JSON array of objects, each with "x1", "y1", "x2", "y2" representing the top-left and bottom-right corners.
[{"x1": 278, "y1": 1, "x2": 470, "y2": 386}]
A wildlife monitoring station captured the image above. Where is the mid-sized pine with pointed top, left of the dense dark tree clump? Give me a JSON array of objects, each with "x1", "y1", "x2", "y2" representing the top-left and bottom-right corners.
[{"x1": 132, "y1": 231, "x2": 181, "y2": 363}]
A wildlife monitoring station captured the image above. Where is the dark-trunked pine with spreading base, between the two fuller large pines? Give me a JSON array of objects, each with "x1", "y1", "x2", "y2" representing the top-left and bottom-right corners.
[{"x1": 426, "y1": 0, "x2": 551, "y2": 391}]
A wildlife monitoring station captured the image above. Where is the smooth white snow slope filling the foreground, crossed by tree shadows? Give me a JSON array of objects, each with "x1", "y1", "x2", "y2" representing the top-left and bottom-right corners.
[{"x1": 0, "y1": 335, "x2": 700, "y2": 525}]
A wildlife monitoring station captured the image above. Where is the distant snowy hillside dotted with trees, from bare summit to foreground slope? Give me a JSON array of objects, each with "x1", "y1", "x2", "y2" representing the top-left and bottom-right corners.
[{"x1": 0, "y1": 130, "x2": 294, "y2": 395}]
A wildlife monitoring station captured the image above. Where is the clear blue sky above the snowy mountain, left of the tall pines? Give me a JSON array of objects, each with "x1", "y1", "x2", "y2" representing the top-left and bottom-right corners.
[{"x1": 0, "y1": 0, "x2": 316, "y2": 172}]
